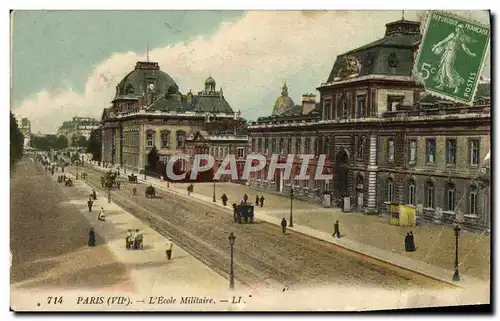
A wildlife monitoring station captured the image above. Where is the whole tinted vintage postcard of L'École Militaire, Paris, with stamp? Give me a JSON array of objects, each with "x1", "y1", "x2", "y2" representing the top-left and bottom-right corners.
[{"x1": 10, "y1": 10, "x2": 492, "y2": 312}]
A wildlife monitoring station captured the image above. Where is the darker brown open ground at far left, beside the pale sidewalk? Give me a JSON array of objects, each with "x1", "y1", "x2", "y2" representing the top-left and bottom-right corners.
[{"x1": 10, "y1": 160, "x2": 131, "y2": 290}]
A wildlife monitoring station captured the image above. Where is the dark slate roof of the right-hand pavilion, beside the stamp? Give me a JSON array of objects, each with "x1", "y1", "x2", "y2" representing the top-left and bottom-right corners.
[{"x1": 327, "y1": 20, "x2": 421, "y2": 82}]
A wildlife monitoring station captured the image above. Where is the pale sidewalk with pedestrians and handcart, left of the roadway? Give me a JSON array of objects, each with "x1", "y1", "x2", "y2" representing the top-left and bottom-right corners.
[{"x1": 48, "y1": 173, "x2": 243, "y2": 295}]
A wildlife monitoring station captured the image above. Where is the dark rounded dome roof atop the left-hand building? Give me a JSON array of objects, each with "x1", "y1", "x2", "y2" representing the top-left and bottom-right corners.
[{"x1": 115, "y1": 61, "x2": 179, "y2": 98}]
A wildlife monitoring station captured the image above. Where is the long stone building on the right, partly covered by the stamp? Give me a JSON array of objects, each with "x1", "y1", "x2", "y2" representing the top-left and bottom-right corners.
[{"x1": 248, "y1": 20, "x2": 491, "y2": 228}]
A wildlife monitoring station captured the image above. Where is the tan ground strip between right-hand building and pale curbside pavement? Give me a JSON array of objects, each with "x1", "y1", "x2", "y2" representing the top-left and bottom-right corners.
[{"x1": 171, "y1": 183, "x2": 491, "y2": 280}]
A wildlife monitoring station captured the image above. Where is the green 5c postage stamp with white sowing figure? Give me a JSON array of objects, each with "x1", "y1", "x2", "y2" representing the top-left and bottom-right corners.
[{"x1": 413, "y1": 11, "x2": 490, "y2": 105}]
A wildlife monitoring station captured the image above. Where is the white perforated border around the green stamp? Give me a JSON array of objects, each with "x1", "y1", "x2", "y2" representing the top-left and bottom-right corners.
[{"x1": 412, "y1": 10, "x2": 491, "y2": 106}]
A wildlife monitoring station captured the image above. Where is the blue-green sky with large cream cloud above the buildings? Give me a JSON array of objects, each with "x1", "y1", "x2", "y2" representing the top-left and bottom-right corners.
[{"x1": 10, "y1": 11, "x2": 490, "y2": 133}]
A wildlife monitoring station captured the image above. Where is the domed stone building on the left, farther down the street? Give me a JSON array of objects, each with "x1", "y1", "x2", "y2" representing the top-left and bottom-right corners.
[{"x1": 102, "y1": 61, "x2": 248, "y2": 178}]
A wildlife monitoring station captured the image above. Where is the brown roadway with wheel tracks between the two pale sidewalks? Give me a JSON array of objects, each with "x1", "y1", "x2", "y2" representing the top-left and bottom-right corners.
[{"x1": 75, "y1": 167, "x2": 450, "y2": 289}]
